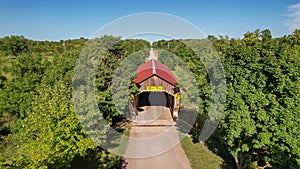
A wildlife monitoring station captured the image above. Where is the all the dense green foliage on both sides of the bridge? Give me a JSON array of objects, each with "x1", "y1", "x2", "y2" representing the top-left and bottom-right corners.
[{"x1": 0, "y1": 30, "x2": 300, "y2": 169}]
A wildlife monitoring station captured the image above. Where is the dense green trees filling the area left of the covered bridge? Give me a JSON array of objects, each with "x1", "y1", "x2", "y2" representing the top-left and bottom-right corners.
[{"x1": 0, "y1": 36, "x2": 150, "y2": 169}]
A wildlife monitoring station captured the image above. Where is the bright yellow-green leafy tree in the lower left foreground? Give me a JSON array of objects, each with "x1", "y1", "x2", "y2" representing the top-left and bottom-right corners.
[{"x1": 3, "y1": 81, "x2": 95, "y2": 168}]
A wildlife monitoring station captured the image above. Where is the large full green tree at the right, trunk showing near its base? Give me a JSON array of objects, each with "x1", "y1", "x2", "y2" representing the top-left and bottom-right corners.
[{"x1": 221, "y1": 31, "x2": 299, "y2": 168}]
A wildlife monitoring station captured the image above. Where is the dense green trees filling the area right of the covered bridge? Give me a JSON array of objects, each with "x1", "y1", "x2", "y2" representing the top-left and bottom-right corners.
[{"x1": 154, "y1": 30, "x2": 300, "y2": 169}]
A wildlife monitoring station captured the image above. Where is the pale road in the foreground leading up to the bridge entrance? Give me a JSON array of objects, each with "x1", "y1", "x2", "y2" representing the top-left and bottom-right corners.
[{"x1": 125, "y1": 106, "x2": 191, "y2": 169}]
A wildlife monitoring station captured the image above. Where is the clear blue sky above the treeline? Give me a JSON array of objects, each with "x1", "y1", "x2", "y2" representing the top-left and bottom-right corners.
[{"x1": 0, "y1": 0, "x2": 300, "y2": 40}]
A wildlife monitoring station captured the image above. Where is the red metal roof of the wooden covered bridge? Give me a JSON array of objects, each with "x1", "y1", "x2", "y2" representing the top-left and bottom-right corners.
[{"x1": 134, "y1": 59, "x2": 176, "y2": 85}]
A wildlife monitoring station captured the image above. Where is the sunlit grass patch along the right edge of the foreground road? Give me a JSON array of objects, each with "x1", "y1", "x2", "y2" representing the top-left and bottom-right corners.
[{"x1": 181, "y1": 136, "x2": 224, "y2": 169}]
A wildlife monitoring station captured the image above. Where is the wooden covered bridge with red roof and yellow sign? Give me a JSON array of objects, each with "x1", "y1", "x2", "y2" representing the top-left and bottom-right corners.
[{"x1": 133, "y1": 58, "x2": 180, "y2": 120}]
